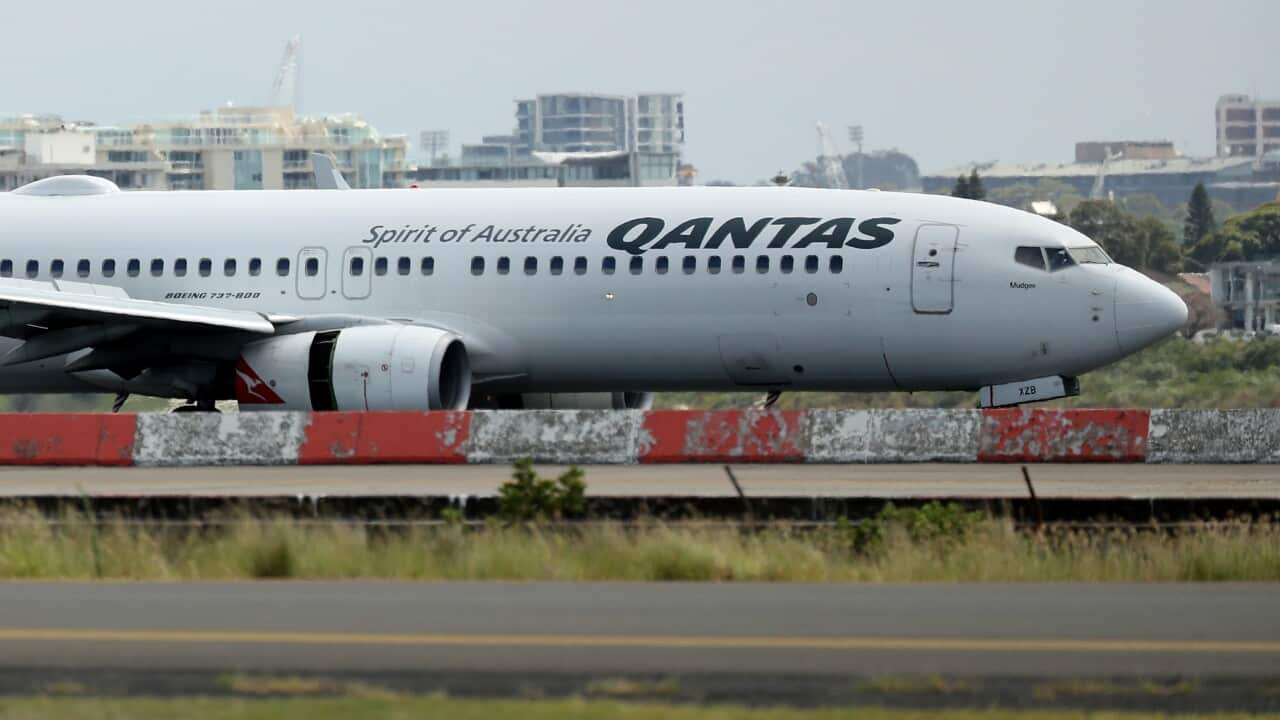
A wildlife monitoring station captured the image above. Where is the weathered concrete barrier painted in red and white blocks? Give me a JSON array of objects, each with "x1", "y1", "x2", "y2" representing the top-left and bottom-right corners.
[{"x1": 0, "y1": 409, "x2": 1280, "y2": 465}]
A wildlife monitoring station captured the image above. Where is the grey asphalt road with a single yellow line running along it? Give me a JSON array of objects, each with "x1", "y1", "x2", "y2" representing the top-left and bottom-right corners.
[{"x1": 0, "y1": 582, "x2": 1280, "y2": 684}]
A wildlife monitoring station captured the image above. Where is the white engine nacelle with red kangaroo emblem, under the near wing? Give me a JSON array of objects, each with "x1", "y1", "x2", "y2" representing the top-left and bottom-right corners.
[{"x1": 236, "y1": 325, "x2": 471, "y2": 410}]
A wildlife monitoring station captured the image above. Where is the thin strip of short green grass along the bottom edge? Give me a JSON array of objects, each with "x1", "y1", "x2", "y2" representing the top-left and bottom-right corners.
[{"x1": 0, "y1": 697, "x2": 1277, "y2": 720}]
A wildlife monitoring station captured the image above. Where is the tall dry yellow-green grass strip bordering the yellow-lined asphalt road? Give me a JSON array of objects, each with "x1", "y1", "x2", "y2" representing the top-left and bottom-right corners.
[{"x1": 0, "y1": 505, "x2": 1280, "y2": 582}]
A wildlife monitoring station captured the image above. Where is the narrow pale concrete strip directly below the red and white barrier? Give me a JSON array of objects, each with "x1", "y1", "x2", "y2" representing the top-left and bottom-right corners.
[{"x1": 0, "y1": 464, "x2": 1280, "y2": 498}]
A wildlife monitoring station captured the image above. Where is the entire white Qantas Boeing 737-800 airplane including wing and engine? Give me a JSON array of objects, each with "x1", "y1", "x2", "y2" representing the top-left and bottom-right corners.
[{"x1": 0, "y1": 156, "x2": 1187, "y2": 411}]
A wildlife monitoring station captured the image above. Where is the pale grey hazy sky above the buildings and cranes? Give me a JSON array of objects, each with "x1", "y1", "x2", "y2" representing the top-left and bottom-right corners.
[{"x1": 0, "y1": 0, "x2": 1280, "y2": 182}]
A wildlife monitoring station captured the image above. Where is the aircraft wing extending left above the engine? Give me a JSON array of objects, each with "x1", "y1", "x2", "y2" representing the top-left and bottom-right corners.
[{"x1": 0, "y1": 278, "x2": 282, "y2": 365}]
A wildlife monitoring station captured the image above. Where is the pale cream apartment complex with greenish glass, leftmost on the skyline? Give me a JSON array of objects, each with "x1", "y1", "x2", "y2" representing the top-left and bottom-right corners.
[{"x1": 0, "y1": 108, "x2": 408, "y2": 191}]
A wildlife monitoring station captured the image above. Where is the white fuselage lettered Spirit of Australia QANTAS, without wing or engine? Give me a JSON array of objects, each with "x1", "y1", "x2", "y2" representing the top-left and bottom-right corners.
[{"x1": 0, "y1": 187, "x2": 1185, "y2": 392}]
